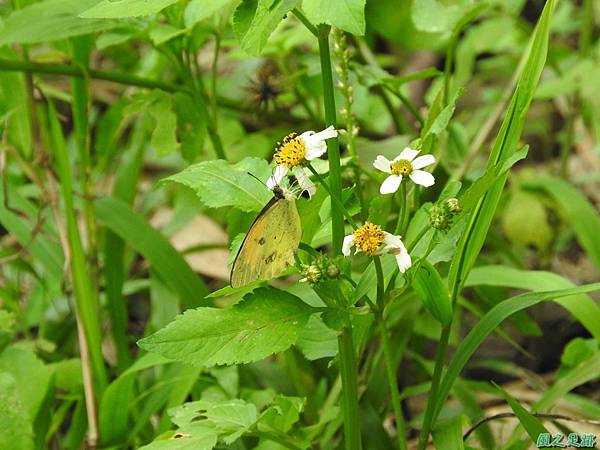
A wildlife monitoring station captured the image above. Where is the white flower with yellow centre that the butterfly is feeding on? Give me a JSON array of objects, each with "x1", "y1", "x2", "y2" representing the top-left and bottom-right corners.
[{"x1": 267, "y1": 126, "x2": 338, "y2": 195}]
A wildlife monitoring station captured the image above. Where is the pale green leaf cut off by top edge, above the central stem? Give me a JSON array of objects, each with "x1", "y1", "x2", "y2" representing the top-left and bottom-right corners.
[{"x1": 302, "y1": 0, "x2": 366, "y2": 36}]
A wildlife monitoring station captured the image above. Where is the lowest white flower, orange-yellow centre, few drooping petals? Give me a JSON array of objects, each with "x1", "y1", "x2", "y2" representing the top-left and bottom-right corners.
[{"x1": 342, "y1": 222, "x2": 412, "y2": 273}]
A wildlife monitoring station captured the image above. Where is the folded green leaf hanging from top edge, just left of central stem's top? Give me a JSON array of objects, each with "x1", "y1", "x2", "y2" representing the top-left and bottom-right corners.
[{"x1": 233, "y1": 0, "x2": 300, "y2": 55}]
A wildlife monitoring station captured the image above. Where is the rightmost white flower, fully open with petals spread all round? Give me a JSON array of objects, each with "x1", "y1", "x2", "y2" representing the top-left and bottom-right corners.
[{"x1": 373, "y1": 147, "x2": 435, "y2": 194}]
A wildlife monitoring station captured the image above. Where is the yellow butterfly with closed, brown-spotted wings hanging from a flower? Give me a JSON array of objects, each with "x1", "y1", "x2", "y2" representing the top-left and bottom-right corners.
[{"x1": 230, "y1": 186, "x2": 302, "y2": 288}]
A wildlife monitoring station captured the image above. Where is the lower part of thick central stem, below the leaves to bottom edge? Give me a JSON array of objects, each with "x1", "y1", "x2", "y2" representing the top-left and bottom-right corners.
[{"x1": 338, "y1": 327, "x2": 362, "y2": 450}]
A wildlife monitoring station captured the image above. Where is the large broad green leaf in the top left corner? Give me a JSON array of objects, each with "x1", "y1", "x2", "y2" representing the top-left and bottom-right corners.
[{"x1": 0, "y1": 0, "x2": 117, "y2": 46}]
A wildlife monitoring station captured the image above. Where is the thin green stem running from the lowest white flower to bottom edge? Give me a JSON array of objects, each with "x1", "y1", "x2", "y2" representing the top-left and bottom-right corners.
[{"x1": 373, "y1": 256, "x2": 407, "y2": 450}]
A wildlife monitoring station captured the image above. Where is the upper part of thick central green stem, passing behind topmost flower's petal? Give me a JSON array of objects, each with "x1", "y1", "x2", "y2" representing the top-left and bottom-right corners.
[{"x1": 318, "y1": 25, "x2": 344, "y2": 255}]
